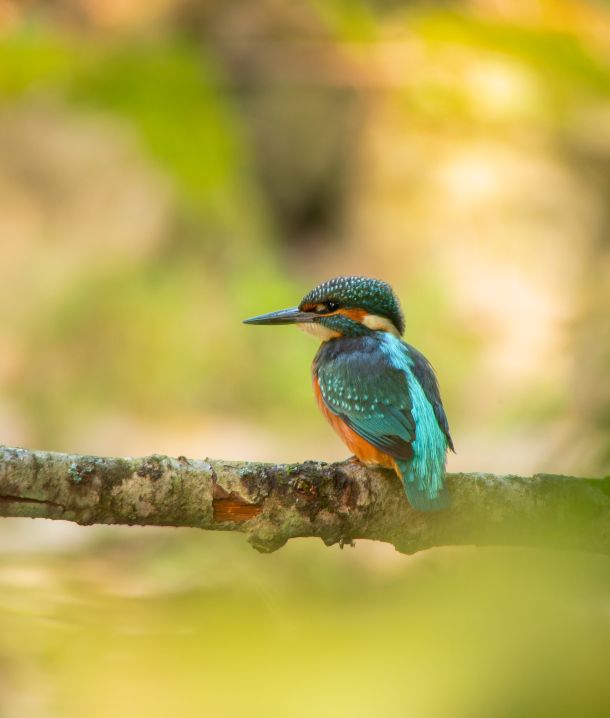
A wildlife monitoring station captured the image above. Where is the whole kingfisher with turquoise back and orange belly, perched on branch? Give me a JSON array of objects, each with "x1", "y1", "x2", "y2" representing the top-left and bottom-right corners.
[{"x1": 244, "y1": 276, "x2": 455, "y2": 511}]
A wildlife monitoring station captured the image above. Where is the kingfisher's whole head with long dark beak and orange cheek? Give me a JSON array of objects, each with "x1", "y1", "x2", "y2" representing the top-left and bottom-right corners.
[{"x1": 245, "y1": 277, "x2": 405, "y2": 341}]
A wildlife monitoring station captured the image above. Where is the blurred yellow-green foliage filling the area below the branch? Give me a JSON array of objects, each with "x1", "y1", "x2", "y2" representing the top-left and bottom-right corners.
[{"x1": 0, "y1": 531, "x2": 610, "y2": 718}]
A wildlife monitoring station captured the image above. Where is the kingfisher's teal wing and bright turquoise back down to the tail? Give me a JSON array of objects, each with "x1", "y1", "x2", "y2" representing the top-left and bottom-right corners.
[{"x1": 315, "y1": 337, "x2": 447, "y2": 511}]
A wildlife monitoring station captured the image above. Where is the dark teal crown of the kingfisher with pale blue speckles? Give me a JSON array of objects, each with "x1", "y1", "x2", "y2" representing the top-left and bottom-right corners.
[{"x1": 299, "y1": 277, "x2": 405, "y2": 334}]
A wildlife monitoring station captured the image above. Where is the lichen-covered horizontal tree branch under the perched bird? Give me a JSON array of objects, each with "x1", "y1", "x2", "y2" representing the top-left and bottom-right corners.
[{"x1": 0, "y1": 447, "x2": 610, "y2": 553}]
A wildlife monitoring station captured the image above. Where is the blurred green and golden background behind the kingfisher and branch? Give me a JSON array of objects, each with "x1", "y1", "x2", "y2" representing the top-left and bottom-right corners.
[{"x1": 0, "y1": 0, "x2": 610, "y2": 718}]
